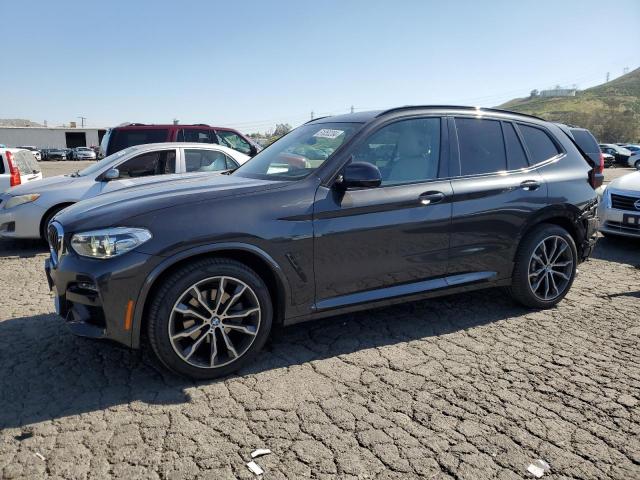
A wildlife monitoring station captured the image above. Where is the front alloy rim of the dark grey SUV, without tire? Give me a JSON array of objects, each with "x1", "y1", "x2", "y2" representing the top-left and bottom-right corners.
[{"x1": 169, "y1": 276, "x2": 262, "y2": 369}]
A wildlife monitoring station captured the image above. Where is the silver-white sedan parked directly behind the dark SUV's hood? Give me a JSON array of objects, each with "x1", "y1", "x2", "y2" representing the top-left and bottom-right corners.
[{"x1": 0, "y1": 142, "x2": 250, "y2": 239}]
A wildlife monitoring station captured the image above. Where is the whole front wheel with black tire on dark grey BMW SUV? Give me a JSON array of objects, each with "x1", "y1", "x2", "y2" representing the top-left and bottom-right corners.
[{"x1": 146, "y1": 258, "x2": 273, "y2": 380}]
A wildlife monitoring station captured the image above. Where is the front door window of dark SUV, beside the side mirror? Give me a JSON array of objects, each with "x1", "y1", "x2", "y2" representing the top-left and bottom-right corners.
[{"x1": 354, "y1": 118, "x2": 440, "y2": 185}]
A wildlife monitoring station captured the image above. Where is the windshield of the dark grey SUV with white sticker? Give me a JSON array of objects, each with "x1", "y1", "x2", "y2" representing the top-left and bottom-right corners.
[{"x1": 236, "y1": 123, "x2": 362, "y2": 180}]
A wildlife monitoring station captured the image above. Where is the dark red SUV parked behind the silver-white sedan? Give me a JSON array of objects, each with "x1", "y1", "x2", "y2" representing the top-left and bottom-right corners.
[{"x1": 100, "y1": 123, "x2": 261, "y2": 157}]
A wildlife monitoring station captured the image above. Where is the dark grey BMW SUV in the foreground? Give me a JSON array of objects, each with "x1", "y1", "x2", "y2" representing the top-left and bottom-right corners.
[{"x1": 46, "y1": 106, "x2": 601, "y2": 378}]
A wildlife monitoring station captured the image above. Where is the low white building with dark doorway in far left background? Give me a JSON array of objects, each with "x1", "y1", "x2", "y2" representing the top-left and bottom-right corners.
[{"x1": 0, "y1": 126, "x2": 107, "y2": 148}]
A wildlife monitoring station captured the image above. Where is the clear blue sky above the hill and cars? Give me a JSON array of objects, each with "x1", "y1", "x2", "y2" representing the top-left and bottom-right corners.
[{"x1": 0, "y1": 0, "x2": 640, "y2": 132}]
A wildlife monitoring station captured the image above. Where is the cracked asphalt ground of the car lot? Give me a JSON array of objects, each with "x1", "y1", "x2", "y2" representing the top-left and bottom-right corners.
[{"x1": 0, "y1": 162, "x2": 640, "y2": 479}]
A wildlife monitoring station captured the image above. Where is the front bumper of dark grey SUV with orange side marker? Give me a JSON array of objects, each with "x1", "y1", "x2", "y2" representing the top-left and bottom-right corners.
[{"x1": 45, "y1": 246, "x2": 160, "y2": 347}]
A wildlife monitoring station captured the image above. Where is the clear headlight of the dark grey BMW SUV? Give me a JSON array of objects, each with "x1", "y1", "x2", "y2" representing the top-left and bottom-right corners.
[{"x1": 71, "y1": 227, "x2": 152, "y2": 258}]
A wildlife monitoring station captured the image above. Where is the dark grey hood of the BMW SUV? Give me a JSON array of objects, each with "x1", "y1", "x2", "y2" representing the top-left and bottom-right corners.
[{"x1": 56, "y1": 174, "x2": 289, "y2": 231}]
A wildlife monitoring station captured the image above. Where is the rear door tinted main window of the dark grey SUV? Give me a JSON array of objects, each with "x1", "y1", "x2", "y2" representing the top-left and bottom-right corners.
[{"x1": 456, "y1": 118, "x2": 507, "y2": 175}]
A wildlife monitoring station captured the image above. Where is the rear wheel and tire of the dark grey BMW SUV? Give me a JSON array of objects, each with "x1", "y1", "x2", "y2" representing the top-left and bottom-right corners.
[{"x1": 509, "y1": 223, "x2": 578, "y2": 308}]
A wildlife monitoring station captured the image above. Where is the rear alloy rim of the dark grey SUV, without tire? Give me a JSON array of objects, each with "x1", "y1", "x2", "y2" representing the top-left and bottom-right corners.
[{"x1": 529, "y1": 235, "x2": 573, "y2": 301}]
